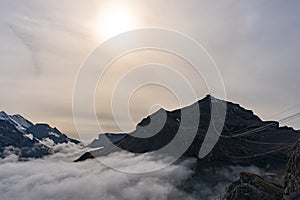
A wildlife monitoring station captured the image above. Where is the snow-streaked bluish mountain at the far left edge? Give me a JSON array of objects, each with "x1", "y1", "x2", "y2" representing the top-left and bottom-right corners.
[{"x1": 0, "y1": 111, "x2": 79, "y2": 158}]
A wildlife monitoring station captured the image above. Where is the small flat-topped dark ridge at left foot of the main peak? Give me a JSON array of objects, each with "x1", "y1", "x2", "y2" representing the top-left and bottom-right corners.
[{"x1": 88, "y1": 133, "x2": 127, "y2": 148}]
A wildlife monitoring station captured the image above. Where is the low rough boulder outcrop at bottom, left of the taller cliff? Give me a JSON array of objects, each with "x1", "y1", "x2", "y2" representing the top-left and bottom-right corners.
[{"x1": 221, "y1": 172, "x2": 284, "y2": 200}]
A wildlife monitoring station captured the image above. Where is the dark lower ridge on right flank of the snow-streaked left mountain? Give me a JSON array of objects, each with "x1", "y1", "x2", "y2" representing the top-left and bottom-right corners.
[{"x1": 26, "y1": 124, "x2": 80, "y2": 144}]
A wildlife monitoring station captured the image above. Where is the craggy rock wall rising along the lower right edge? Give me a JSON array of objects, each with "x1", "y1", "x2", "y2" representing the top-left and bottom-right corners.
[{"x1": 285, "y1": 141, "x2": 300, "y2": 199}]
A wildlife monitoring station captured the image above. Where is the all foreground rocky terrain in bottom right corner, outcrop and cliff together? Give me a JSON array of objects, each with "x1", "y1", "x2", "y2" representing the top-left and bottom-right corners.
[{"x1": 221, "y1": 141, "x2": 300, "y2": 200}]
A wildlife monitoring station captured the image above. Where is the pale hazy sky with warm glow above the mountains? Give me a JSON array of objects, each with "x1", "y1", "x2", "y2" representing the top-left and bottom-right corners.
[{"x1": 0, "y1": 0, "x2": 300, "y2": 136}]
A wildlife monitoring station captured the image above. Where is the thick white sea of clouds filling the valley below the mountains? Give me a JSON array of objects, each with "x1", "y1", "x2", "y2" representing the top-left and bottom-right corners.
[{"x1": 0, "y1": 143, "x2": 262, "y2": 200}]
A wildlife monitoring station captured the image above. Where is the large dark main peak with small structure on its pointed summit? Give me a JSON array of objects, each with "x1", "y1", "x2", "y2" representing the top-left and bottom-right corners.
[{"x1": 76, "y1": 95, "x2": 300, "y2": 170}]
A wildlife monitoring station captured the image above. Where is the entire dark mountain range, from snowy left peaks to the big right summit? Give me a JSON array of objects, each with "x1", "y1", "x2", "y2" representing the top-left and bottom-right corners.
[{"x1": 0, "y1": 95, "x2": 300, "y2": 200}]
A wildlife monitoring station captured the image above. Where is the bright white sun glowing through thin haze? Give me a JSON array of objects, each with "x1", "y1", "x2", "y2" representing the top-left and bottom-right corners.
[{"x1": 99, "y1": 6, "x2": 135, "y2": 38}]
